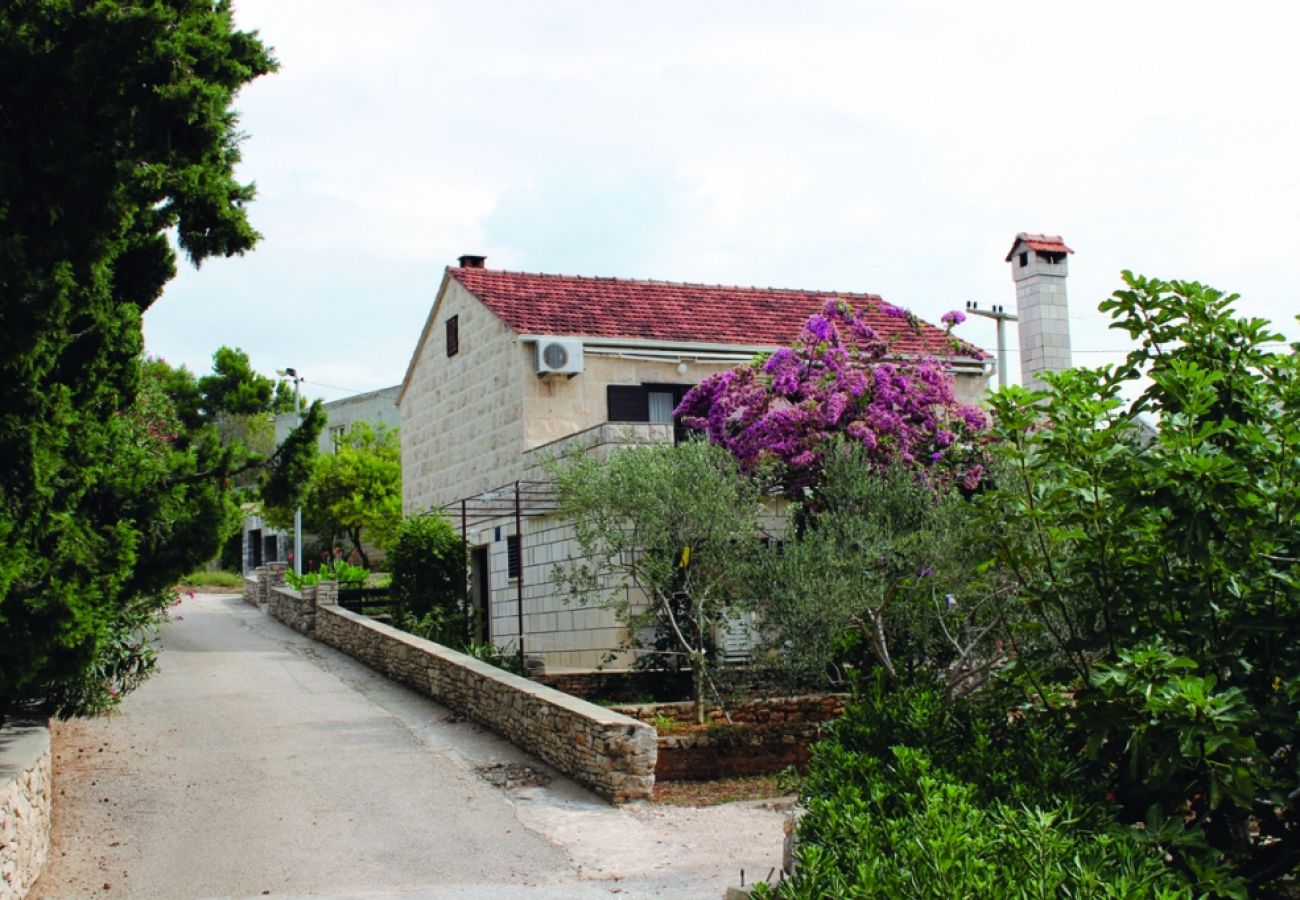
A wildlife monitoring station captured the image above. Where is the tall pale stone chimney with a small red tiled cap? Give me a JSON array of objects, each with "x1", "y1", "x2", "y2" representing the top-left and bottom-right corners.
[{"x1": 1006, "y1": 232, "x2": 1074, "y2": 390}]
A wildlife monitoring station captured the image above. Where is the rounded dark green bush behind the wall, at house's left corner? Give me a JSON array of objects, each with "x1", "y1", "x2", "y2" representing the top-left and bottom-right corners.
[{"x1": 389, "y1": 515, "x2": 469, "y2": 646}]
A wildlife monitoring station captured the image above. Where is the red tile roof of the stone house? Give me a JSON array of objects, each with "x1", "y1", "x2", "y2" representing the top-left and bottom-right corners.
[{"x1": 447, "y1": 267, "x2": 974, "y2": 356}]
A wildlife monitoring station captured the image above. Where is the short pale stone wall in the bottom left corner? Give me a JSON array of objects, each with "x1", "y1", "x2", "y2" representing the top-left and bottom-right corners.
[{"x1": 0, "y1": 722, "x2": 52, "y2": 900}]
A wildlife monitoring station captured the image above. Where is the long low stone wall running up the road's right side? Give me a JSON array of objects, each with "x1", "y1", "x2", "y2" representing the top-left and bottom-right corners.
[{"x1": 260, "y1": 574, "x2": 658, "y2": 804}]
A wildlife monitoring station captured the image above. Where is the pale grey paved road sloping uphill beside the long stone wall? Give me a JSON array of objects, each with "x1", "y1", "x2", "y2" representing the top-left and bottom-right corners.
[{"x1": 33, "y1": 596, "x2": 781, "y2": 899}]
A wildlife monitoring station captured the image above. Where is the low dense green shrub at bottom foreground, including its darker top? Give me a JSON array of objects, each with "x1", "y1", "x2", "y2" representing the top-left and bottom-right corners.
[{"x1": 758, "y1": 672, "x2": 1192, "y2": 899}]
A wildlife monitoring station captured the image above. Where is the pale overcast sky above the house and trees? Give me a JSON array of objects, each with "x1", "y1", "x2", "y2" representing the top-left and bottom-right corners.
[{"x1": 146, "y1": 0, "x2": 1300, "y2": 399}]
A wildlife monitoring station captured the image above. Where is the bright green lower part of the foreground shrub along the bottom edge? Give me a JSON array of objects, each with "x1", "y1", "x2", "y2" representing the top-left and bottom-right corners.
[{"x1": 758, "y1": 747, "x2": 1192, "y2": 900}]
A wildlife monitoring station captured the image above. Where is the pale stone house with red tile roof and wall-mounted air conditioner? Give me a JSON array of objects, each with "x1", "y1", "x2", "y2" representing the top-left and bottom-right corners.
[{"x1": 398, "y1": 256, "x2": 988, "y2": 668}]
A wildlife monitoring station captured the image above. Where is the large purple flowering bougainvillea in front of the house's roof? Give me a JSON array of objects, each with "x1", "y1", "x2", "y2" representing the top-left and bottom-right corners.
[{"x1": 677, "y1": 300, "x2": 988, "y2": 489}]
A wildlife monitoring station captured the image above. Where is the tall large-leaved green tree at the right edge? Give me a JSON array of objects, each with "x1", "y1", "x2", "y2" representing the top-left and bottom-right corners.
[{"x1": 979, "y1": 272, "x2": 1300, "y2": 891}]
